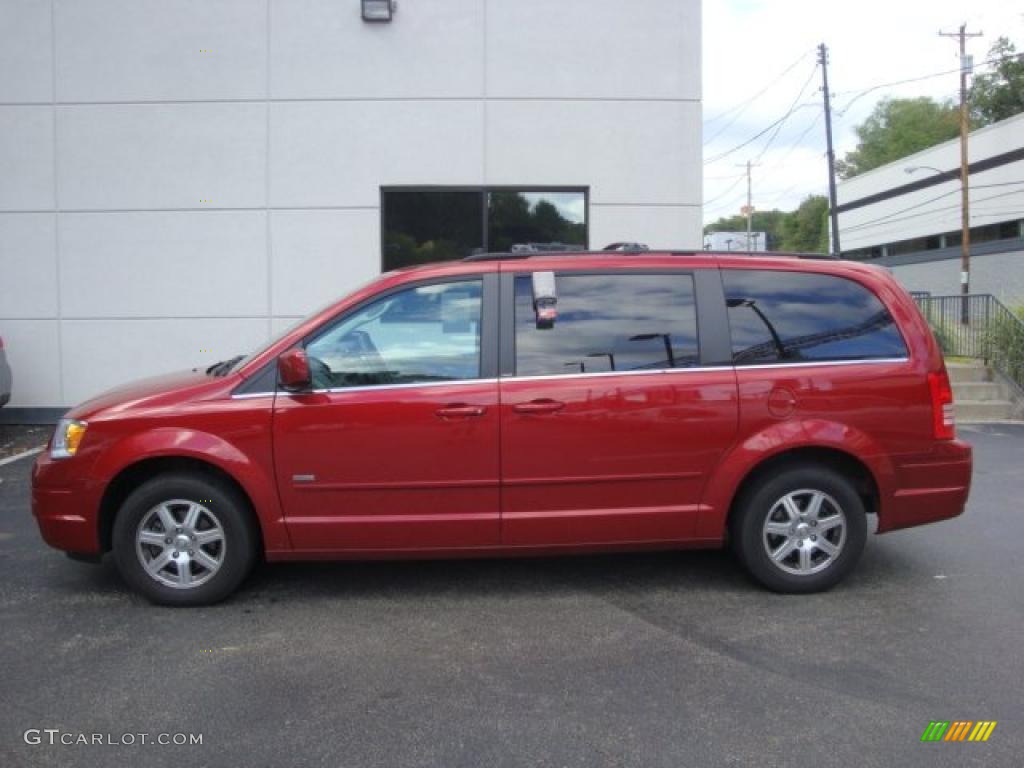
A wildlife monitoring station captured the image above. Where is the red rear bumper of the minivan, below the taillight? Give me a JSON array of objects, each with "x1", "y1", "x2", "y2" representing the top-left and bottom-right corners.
[{"x1": 879, "y1": 440, "x2": 974, "y2": 534}]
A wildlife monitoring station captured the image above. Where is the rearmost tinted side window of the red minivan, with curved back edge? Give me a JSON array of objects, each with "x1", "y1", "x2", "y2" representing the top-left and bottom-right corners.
[{"x1": 722, "y1": 269, "x2": 906, "y2": 366}]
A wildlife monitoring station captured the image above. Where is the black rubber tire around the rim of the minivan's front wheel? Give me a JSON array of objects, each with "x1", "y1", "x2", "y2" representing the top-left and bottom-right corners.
[{"x1": 113, "y1": 473, "x2": 257, "y2": 605}]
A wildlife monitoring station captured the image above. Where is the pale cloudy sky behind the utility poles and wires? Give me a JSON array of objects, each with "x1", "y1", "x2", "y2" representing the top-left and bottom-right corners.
[{"x1": 703, "y1": 0, "x2": 1024, "y2": 223}]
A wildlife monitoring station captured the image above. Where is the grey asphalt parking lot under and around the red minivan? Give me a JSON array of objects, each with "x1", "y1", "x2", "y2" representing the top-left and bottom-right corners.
[{"x1": 0, "y1": 425, "x2": 1024, "y2": 768}]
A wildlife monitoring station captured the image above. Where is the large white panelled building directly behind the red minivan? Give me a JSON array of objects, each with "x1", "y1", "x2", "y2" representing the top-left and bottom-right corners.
[{"x1": 0, "y1": 0, "x2": 701, "y2": 421}]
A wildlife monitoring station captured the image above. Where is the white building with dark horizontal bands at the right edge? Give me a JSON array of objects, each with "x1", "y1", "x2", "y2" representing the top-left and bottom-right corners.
[{"x1": 837, "y1": 114, "x2": 1024, "y2": 304}]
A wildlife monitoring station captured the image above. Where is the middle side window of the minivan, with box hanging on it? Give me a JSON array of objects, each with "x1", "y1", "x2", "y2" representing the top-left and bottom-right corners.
[{"x1": 515, "y1": 273, "x2": 698, "y2": 376}]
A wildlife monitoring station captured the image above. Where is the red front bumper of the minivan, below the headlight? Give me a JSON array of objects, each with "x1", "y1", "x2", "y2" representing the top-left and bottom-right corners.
[{"x1": 32, "y1": 452, "x2": 102, "y2": 555}]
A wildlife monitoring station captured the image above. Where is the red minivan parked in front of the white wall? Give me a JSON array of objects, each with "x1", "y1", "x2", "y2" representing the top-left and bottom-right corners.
[{"x1": 32, "y1": 252, "x2": 971, "y2": 605}]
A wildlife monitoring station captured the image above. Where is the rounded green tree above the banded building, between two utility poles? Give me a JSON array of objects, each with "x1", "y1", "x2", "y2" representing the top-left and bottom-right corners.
[{"x1": 836, "y1": 96, "x2": 959, "y2": 178}]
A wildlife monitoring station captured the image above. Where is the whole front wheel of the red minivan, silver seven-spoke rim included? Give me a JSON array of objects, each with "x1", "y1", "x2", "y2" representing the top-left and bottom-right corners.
[{"x1": 113, "y1": 474, "x2": 256, "y2": 605}]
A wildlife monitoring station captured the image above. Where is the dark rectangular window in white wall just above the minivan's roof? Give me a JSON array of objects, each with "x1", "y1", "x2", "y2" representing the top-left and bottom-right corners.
[{"x1": 381, "y1": 187, "x2": 587, "y2": 271}]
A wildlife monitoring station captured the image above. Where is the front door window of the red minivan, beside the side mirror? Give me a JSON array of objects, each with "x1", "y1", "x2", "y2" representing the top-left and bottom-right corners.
[{"x1": 306, "y1": 280, "x2": 480, "y2": 389}]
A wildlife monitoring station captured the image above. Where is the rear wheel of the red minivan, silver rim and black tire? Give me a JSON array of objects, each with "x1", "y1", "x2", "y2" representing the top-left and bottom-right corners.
[{"x1": 730, "y1": 465, "x2": 867, "y2": 594}]
